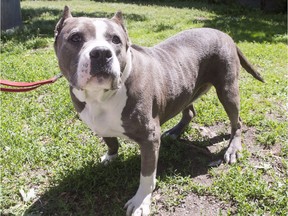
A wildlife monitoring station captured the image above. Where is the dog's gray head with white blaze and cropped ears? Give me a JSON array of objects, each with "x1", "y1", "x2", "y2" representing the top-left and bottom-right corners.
[{"x1": 54, "y1": 6, "x2": 131, "y2": 90}]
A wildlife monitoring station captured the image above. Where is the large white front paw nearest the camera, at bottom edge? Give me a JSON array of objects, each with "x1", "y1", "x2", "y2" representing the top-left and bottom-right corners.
[{"x1": 124, "y1": 193, "x2": 151, "y2": 216}]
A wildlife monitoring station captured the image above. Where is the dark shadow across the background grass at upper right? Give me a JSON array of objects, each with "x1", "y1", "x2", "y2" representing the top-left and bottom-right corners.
[{"x1": 96, "y1": 0, "x2": 287, "y2": 44}]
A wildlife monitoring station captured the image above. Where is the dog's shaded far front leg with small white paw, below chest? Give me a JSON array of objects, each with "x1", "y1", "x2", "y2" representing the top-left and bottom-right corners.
[{"x1": 101, "y1": 137, "x2": 119, "y2": 165}]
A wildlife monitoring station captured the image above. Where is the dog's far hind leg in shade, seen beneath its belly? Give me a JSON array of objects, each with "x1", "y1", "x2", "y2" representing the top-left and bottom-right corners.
[{"x1": 162, "y1": 104, "x2": 196, "y2": 139}]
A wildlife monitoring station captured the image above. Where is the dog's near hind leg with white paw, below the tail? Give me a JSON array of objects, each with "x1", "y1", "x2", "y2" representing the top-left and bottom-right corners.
[{"x1": 215, "y1": 79, "x2": 242, "y2": 163}]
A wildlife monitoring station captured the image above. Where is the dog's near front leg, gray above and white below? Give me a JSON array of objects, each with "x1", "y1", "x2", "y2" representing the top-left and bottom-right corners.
[{"x1": 124, "y1": 134, "x2": 160, "y2": 216}]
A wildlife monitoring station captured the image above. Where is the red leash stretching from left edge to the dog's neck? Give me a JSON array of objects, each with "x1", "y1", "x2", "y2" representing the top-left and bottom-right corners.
[{"x1": 0, "y1": 73, "x2": 63, "y2": 92}]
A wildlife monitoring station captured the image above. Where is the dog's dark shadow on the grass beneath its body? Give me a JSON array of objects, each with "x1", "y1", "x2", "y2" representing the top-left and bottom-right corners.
[{"x1": 24, "y1": 135, "x2": 229, "y2": 216}]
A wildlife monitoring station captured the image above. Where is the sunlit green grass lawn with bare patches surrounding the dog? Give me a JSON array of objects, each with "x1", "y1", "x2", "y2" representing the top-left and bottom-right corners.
[{"x1": 0, "y1": 0, "x2": 288, "y2": 216}]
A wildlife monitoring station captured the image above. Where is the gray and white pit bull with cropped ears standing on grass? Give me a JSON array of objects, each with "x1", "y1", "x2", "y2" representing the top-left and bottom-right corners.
[{"x1": 55, "y1": 7, "x2": 264, "y2": 215}]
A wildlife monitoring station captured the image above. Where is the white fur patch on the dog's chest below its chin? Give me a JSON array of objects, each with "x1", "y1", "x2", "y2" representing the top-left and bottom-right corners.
[{"x1": 72, "y1": 85, "x2": 127, "y2": 137}]
